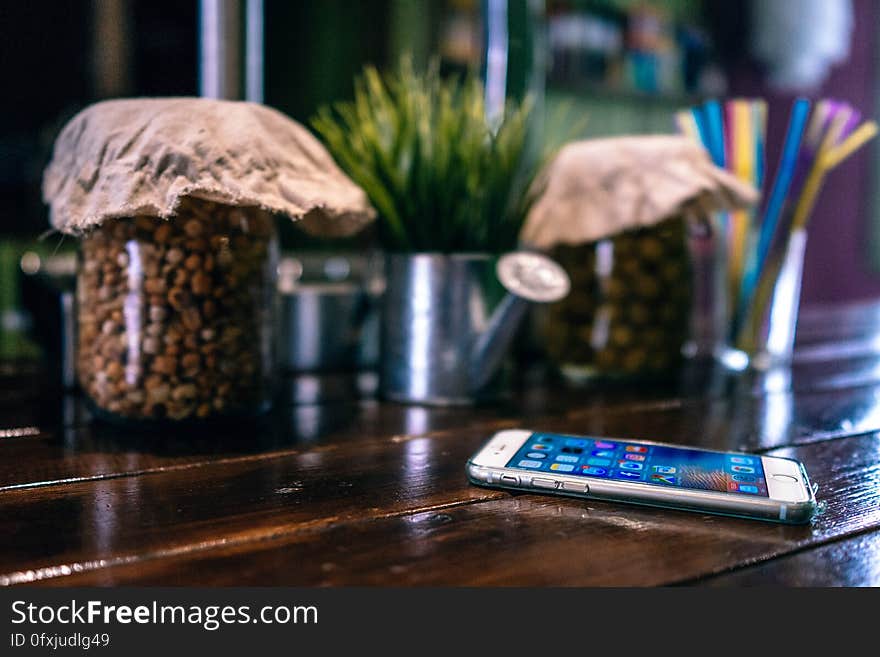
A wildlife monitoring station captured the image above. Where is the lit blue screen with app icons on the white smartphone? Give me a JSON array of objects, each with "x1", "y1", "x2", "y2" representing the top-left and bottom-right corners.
[{"x1": 507, "y1": 433, "x2": 768, "y2": 497}]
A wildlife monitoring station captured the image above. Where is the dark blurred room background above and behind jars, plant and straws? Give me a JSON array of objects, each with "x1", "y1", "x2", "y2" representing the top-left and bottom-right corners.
[{"x1": 0, "y1": 0, "x2": 880, "y2": 357}]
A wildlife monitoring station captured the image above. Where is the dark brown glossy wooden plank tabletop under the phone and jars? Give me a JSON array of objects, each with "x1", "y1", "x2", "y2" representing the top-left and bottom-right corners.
[{"x1": 0, "y1": 304, "x2": 880, "y2": 586}]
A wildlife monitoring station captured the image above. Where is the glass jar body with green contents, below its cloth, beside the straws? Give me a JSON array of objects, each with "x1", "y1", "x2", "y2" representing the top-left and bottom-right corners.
[{"x1": 545, "y1": 219, "x2": 692, "y2": 381}]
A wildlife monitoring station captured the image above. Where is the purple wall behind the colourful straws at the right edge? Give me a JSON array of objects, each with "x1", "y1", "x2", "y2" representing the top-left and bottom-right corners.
[{"x1": 730, "y1": 0, "x2": 880, "y2": 303}]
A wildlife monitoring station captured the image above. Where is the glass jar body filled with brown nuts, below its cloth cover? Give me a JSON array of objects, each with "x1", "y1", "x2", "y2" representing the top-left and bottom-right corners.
[{"x1": 76, "y1": 198, "x2": 277, "y2": 421}]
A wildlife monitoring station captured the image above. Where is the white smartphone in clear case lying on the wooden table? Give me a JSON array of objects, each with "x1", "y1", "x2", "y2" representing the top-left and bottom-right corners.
[{"x1": 467, "y1": 429, "x2": 816, "y2": 524}]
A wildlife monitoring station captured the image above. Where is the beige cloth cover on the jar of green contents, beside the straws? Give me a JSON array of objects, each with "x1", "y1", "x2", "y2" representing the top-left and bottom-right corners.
[{"x1": 520, "y1": 135, "x2": 758, "y2": 249}]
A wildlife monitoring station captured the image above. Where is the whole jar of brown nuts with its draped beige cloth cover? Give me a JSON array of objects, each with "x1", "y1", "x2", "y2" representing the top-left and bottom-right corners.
[{"x1": 43, "y1": 98, "x2": 375, "y2": 421}]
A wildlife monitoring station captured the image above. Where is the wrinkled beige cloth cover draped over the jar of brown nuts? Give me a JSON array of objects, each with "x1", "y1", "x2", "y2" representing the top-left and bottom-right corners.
[{"x1": 43, "y1": 98, "x2": 376, "y2": 237}]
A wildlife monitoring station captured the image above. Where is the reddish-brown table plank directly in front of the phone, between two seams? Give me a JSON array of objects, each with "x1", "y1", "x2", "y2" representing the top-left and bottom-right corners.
[{"x1": 24, "y1": 436, "x2": 880, "y2": 586}]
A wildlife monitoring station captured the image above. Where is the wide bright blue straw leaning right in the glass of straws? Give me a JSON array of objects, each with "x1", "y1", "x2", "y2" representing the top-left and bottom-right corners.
[{"x1": 738, "y1": 98, "x2": 810, "y2": 330}]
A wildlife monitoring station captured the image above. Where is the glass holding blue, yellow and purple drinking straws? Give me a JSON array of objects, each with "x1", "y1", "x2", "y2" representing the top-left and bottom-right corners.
[{"x1": 675, "y1": 98, "x2": 877, "y2": 369}]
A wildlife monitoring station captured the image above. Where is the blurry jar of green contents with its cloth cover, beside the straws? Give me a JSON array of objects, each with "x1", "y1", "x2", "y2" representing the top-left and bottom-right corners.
[{"x1": 521, "y1": 135, "x2": 757, "y2": 380}]
